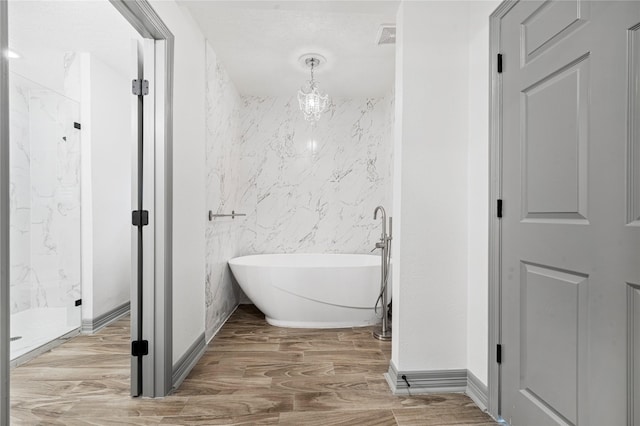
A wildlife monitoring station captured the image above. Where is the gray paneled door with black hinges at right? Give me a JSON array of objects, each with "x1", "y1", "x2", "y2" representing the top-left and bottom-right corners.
[{"x1": 500, "y1": 0, "x2": 640, "y2": 425}]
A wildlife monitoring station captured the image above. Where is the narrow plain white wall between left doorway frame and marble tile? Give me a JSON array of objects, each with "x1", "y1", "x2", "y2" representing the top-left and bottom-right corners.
[{"x1": 150, "y1": 0, "x2": 207, "y2": 363}]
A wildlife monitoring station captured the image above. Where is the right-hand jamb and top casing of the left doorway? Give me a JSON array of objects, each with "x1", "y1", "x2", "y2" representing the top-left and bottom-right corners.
[{"x1": 109, "y1": 0, "x2": 174, "y2": 398}]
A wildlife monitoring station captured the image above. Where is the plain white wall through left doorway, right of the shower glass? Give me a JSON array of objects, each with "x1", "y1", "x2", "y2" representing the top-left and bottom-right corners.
[{"x1": 82, "y1": 55, "x2": 132, "y2": 320}]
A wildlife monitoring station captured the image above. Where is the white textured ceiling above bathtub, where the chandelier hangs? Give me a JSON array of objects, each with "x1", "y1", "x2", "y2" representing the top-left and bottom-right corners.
[{"x1": 179, "y1": 0, "x2": 399, "y2": 97}]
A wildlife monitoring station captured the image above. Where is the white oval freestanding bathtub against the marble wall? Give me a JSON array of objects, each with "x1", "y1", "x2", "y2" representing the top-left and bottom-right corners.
[{"x1": 229, "y1": 254, "x2": 390, "y2": 328}]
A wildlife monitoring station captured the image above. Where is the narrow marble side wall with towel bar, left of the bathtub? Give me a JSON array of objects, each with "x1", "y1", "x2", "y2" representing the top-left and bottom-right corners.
[{"x1": 205, "y1": 44, "x2": 241, "y2": 339}]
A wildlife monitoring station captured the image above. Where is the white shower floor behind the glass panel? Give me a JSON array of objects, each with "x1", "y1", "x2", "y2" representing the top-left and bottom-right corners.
[{"x1": 11, "y1": 308, "x2": 80, "y2": 365}]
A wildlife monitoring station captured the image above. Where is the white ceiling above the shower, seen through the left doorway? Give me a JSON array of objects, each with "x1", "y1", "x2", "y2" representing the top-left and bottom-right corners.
[{"x1": 9, "y1": 0, "x2": 139, "y2": 83}]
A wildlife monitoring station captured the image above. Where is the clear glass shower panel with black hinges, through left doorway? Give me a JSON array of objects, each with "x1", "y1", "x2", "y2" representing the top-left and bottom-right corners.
[{"x1": 9, "y1": 72, "x2": 81, "y2": 361}]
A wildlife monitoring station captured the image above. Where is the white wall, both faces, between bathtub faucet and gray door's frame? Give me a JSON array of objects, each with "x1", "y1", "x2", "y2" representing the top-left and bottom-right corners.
[{"x1": 392, "y1": 0, "x2": 500, "y2": 384}]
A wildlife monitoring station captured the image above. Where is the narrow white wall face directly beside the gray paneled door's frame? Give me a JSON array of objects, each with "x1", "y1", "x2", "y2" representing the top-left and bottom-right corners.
[{"x1": 467, "y1": 0, "x2": 500, "y2": 384}]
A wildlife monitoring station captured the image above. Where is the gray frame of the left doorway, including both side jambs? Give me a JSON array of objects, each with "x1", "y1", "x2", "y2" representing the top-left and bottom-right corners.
[{"x1": 0, "y1": 0, "x2": 174, "y2": 425}]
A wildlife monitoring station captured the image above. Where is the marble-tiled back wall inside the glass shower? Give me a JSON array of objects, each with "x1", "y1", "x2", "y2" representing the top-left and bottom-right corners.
[{"x1": 29, "y1": 90, "x2": 81, "y2": 307}]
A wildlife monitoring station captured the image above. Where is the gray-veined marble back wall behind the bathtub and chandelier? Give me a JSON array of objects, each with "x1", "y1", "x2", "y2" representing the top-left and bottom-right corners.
[{"x1": 240, "y1": 95, "x2": 393, "y2": 254}]
